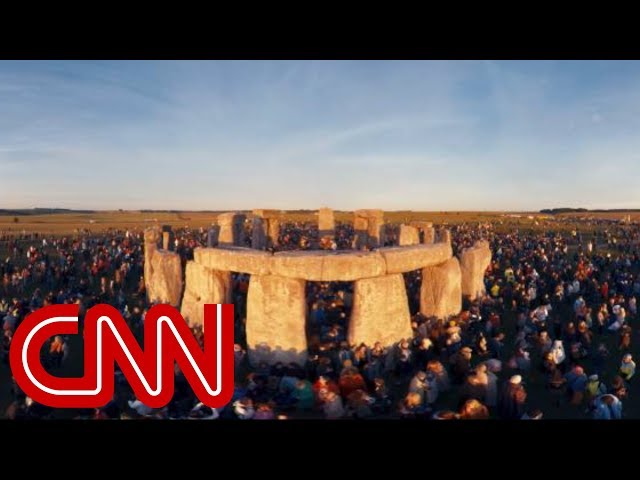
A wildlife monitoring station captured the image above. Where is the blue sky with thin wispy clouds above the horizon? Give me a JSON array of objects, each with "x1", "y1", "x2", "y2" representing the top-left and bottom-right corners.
[{"x1": 0, "y1": 61, "x2": 640, "y2": 210}]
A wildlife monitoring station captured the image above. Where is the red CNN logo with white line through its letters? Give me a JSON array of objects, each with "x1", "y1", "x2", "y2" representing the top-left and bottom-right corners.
[{"x1": 9, "y1": 304, "x2": 234, "y2": 408}]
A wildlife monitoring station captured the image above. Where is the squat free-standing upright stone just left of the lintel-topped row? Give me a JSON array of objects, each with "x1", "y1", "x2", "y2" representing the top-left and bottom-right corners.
[{"x1": 148, "y1": 250, "x2": 182, "y2": 307}]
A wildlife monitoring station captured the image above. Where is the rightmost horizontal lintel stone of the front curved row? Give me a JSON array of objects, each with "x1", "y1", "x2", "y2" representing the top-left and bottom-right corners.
[{"x1": 377, "y1": 243, "x2": 453, "y2": 275}]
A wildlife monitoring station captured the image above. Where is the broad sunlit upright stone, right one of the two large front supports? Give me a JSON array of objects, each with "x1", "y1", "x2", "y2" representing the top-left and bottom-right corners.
[{"x1": 348, "y1": 274, "x2": 413, "y2": 346}]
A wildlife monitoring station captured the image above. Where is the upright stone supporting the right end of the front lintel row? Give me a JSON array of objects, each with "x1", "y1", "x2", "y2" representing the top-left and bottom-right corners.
[{"x1": 420, "y1": 257, "x2": 462, "y2": 318}]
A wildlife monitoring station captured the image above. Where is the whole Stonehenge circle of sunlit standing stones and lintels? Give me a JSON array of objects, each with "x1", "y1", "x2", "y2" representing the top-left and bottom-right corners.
[{"x1": 144, "y1": 209, "x2": 491, "y2": 364}]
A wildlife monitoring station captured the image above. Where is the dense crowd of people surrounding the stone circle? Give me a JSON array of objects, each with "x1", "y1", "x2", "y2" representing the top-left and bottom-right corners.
[{"x1": 0, "y1": 221, "x2": 640, "y2": 420}]
